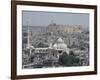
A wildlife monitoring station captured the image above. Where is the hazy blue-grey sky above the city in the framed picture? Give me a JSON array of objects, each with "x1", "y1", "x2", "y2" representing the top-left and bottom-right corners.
[{"x1": 22, "y1": 11, "x2": 89, "y2": 27}]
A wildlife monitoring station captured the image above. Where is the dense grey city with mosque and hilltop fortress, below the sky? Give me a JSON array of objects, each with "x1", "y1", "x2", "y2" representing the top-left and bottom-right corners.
[{"x1": 22, "y1": 22, "x2": 89, "y2": 68}]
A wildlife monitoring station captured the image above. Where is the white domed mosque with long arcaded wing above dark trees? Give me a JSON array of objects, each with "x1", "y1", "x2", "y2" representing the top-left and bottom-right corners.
[{"x1": 27, "y1": 38, "x2": 69, "y2": 59}]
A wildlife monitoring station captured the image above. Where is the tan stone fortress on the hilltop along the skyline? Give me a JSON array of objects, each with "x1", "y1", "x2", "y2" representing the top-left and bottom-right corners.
[{"x1": 46, "y1": 23, "x2": 83, "y2": 33}]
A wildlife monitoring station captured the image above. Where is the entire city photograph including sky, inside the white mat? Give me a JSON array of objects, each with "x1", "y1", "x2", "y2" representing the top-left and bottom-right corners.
[{"x1": 22, "y1": 11, "x2": 90, "y2": 69}]
